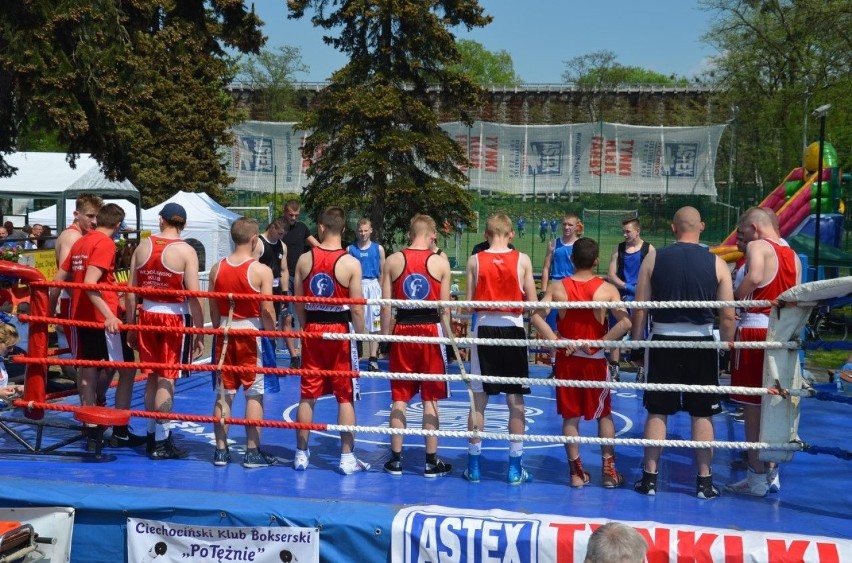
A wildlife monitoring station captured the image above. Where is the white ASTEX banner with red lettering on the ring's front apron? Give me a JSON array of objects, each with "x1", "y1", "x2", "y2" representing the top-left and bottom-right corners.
[{"x1": 391, "y1": 506, "x2": 852, "y2": 563}]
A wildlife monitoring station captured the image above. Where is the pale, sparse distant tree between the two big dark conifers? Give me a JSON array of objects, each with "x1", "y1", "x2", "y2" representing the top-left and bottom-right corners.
[{"x1": 237, "y1": 46, "x2": 309, "y2": 121}]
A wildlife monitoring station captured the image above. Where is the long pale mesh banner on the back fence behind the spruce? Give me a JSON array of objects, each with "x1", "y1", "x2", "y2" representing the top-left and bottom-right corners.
[{"x1": 225, "y1": 121, "x2": 725, "y2": 196}]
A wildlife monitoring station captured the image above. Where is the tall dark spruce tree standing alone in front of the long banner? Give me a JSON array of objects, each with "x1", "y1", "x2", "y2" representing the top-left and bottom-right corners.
[{"x1": 288, "y1": 0, "x2": 490, "y2": 245}]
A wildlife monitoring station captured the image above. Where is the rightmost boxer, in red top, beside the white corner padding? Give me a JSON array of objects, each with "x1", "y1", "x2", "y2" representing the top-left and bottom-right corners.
[{"x1": 727, "y1": 207, "x2": 802, "y2": 497}]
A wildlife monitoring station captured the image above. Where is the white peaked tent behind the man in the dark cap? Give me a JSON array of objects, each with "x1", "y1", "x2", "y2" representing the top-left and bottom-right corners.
[{"x1": 142, "y1": 192, "x2": 240, "y2": 270}]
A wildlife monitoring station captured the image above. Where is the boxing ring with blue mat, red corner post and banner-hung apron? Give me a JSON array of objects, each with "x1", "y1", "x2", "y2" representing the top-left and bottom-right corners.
[{"x1": 0, "y1": 264, "x2": 852, "y2": 562}]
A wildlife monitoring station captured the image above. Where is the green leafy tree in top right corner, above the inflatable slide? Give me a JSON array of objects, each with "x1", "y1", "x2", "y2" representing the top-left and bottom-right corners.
[{"x1": 701, "y1": 0, "x2": 852, "y2": 189}]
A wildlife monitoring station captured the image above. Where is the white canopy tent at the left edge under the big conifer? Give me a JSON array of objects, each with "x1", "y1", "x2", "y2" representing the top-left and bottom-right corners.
[{"x1": 0, "y1": 152, "x2": 141, "y2": 230}]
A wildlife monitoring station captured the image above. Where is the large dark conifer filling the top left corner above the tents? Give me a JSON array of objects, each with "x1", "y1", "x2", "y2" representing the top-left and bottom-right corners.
[{"x1": 0, "y1": 0, "x2": 264, "y2": 205}]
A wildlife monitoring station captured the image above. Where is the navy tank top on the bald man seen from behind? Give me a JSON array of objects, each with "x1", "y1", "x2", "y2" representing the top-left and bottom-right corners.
[{"x1": 648, "y1": 242, "x2": 718, "y2": 325}]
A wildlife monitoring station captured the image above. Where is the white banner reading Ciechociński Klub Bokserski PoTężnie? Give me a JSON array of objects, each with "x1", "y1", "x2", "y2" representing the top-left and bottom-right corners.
[{"x1": 127, "y1": 518, "x2": 319, "y2": 563}]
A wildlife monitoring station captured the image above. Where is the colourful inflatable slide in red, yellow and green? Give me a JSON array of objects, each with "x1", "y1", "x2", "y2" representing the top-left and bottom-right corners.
[{"x1": 713, "y1": 143, "x2": 840, "y2": 262}]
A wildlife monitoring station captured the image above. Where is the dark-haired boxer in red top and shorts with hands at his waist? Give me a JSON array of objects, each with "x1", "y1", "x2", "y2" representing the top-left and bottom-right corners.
[{"x1": 530, "y1": 238, "x2": 631, "y2": 489}]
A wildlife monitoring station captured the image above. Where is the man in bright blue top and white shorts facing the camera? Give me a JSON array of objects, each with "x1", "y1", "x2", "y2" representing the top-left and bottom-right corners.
[{"x1": 347, "y1": 219, "x2": 385, "y2": 371}]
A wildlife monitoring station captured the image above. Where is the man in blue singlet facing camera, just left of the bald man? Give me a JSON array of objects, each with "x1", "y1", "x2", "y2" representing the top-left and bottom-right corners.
[{"x1": 606, "y1": 217, "x2": 654, "y2": 381}]
